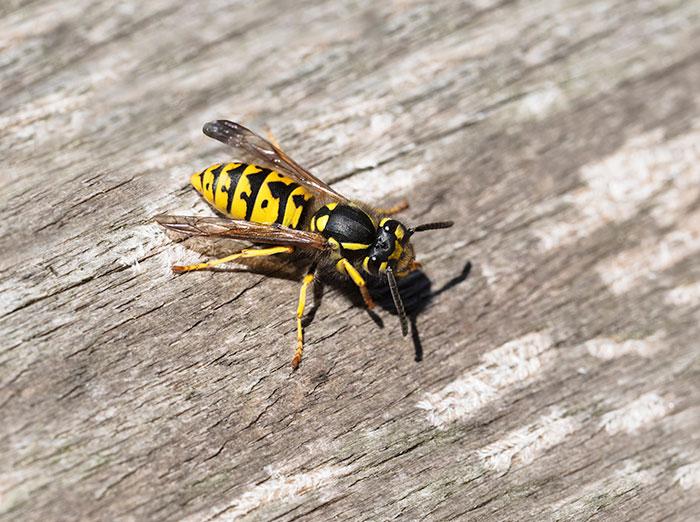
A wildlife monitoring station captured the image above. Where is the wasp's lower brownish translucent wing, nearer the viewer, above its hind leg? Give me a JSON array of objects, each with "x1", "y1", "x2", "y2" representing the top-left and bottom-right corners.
[{"x1": 154, "y1": 214, "x2": 329, "y2": 250}]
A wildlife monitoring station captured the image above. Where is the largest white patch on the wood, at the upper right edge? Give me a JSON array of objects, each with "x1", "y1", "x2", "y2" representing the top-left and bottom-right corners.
[{"x1": 535, "y1": 124, "x2": 700, "y2": 251}]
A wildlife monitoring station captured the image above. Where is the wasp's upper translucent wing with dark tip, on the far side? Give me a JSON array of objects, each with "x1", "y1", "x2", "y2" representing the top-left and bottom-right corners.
[{"x1": 202, "y1": 120, "x2": 348, "y2": 202}]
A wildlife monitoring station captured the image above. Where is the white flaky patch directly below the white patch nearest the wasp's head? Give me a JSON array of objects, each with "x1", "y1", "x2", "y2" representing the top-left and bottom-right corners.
[{"x1": 477, "y1": 407, "x2": 580, "y2": 475}]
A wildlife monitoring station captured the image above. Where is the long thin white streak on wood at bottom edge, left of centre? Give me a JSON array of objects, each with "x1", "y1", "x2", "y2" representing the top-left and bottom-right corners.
[{"x1": 184, "y1": 466, "x2": 352, "y2": 522}]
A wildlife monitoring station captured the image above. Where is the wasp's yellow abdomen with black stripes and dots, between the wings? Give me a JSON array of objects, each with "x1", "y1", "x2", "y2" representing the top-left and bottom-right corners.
[{"x1": 190, "y1": 163, "x2": 312, "y2": 228}]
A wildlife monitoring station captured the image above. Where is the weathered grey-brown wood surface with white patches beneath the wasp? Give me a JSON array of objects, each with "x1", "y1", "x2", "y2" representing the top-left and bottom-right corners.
[{"x1": 0, "y1": 0, "x2": 700, "y2": 521}]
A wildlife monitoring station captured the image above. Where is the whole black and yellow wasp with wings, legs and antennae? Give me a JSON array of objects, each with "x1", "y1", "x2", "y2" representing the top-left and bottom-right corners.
[{"x1": 155, "y1": 120, "x2": 453, "y2": 369}]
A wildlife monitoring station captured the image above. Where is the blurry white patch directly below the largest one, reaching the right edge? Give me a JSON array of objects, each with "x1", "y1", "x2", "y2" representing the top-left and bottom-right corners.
[{"x1": 596, "y1": 211, "x2": 700, "y2": 294}]
